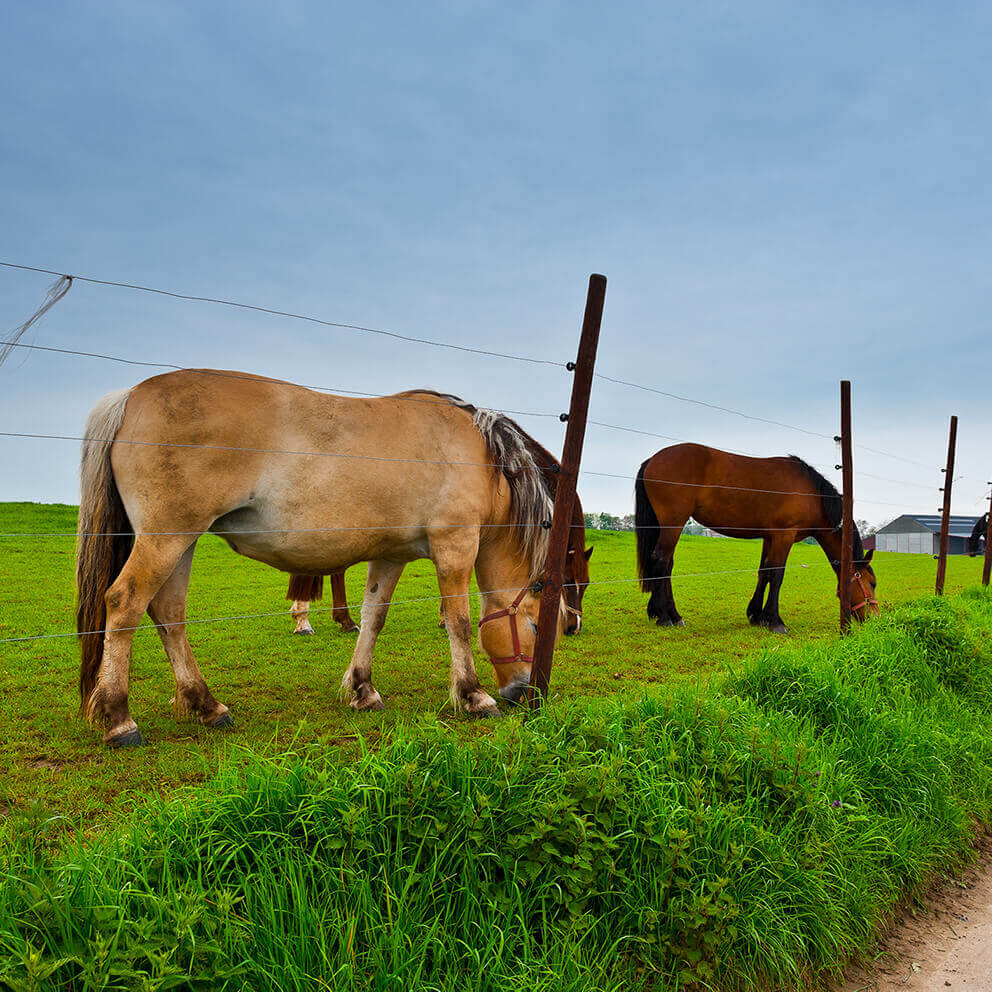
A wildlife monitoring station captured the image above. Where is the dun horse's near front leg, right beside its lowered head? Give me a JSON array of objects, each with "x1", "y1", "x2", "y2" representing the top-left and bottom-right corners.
[{"x1": 431, "y1": 532, "x2": 499, "y2": 716}]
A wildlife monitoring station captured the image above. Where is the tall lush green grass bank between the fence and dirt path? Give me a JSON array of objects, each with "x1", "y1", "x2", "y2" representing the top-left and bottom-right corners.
[{"x1": 0, "y1": 591, "x2": 992, "y2": 992}]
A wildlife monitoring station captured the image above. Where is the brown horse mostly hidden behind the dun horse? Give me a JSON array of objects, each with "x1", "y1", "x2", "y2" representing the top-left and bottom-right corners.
[{"x1": 286, "y1": 406, "x2": 592, "y2": 635}]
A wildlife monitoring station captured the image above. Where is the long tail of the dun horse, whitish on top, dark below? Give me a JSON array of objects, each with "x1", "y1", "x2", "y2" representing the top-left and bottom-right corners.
[{"x1": 76, "y1": 389, "x2": 133, "y2": 708}]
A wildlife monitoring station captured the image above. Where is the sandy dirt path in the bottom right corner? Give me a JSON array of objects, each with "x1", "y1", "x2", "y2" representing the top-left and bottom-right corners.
[{"x1": 835, "y1": 839, "x2": 992, "y2": 992}]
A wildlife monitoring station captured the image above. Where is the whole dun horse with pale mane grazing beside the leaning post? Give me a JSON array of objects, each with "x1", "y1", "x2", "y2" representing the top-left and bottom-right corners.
[{"x1": 77, "y1": 370, "x2": 560, "y2": 746}]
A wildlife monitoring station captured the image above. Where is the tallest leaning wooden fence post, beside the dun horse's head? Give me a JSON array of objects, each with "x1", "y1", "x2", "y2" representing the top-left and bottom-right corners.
[{"x1": 529, "y1": 275, "x2": 606, "y2": 709}]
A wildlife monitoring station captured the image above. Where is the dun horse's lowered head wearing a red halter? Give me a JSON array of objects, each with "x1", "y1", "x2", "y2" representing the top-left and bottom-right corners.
[{"x1": 479, "y1": 586, "x2": 568, "y2": 703}]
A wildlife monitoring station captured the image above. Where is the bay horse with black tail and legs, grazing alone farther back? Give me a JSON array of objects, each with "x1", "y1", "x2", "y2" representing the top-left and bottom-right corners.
[{"x1": 634, "y1": 444, "x2": 878, "y2": 634}]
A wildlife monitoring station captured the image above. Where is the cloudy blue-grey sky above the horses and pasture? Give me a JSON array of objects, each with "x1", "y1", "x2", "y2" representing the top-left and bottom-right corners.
[{"x1": 0, "y1": 0, "x2": 992, "y2": 522}]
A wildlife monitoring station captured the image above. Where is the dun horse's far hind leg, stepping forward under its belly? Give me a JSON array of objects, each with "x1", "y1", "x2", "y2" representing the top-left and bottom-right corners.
[{"x1": 148, "y1": 545, "x2": 232, "y2": 728}]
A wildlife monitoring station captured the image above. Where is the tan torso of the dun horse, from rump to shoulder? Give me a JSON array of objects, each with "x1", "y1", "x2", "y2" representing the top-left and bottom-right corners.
[{"x1": 105, "y1": 370, "x2": 499, "y2": 572}]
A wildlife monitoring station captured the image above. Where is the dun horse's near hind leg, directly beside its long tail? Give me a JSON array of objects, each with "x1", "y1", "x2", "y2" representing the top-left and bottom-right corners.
[{"x1": 83, "y1": 534, "x2": 200, "y2": 747}]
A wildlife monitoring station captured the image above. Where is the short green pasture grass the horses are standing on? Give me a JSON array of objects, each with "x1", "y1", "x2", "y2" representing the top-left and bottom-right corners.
[{"x1": 0, "y1": 503, "x2": 981, "y2": 833}]
